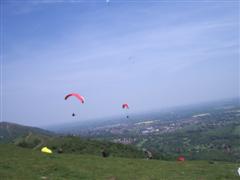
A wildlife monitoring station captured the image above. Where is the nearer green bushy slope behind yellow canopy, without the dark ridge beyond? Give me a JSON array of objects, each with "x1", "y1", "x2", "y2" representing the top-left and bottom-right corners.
[{"x1": 15, "y1": 134, "x2": 144, "y2": 158}]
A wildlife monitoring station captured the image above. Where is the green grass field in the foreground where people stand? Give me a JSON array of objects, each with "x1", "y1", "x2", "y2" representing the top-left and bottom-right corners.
[{"x1": 0, "y1": 145, "x2": 240, "y2": 180}]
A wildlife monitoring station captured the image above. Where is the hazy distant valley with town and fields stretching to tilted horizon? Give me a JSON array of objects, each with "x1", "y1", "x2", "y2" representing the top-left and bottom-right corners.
[{"x1": 49, "y1": 99, "x2": 240, "y2": 161}]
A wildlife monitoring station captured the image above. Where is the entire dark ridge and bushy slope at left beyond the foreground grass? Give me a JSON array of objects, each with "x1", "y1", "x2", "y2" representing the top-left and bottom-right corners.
[{"x1": 0, "y1": 122, "x2": 144, "y2": 158}]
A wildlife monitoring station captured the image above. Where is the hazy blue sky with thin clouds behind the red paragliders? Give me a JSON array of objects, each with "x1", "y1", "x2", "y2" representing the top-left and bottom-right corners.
[{"x1": 1, "y1": 0, "x2": 240, "y2": 126}]
